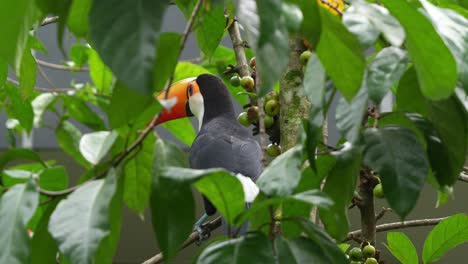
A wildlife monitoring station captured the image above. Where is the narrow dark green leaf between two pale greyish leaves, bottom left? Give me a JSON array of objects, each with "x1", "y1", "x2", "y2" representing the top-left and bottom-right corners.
[{"x1": 30, "y1": 199, "x2": 60, "y2": 264}]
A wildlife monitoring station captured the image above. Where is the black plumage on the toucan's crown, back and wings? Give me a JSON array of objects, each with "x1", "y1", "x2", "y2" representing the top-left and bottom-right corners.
[{"x1": 189, "y1": 74, "x2": 262, "y2": 215}]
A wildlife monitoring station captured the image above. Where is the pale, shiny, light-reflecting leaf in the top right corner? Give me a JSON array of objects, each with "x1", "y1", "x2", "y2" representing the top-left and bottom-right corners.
[{"x1": 421, "y1": 0, "x2": 468, "y2": 91}]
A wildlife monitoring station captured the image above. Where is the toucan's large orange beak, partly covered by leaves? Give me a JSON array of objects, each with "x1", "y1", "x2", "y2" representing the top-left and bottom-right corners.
[{"x1": 156, "y1": 78, "x2": 200, "y2": 125}]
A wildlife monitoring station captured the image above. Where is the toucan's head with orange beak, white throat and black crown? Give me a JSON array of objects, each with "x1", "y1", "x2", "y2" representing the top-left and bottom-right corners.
[{"x1": 156, "y1": 74, "x2": 235, "y2": 127}]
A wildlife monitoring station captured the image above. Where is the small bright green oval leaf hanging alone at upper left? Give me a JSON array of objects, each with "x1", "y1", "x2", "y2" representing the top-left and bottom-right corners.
[{"x1": 18, "y1": 45, "x2": 37, "y2": 96}]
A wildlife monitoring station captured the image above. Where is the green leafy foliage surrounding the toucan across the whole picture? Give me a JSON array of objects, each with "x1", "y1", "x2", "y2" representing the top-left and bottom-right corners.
[{"x1": 0, "y1": 0, "x2": 468, "y2": 263}]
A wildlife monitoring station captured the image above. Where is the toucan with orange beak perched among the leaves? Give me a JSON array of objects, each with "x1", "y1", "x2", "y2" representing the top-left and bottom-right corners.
[{"x1": 157, "y1": 74, "x2": 262, "y2": 235}]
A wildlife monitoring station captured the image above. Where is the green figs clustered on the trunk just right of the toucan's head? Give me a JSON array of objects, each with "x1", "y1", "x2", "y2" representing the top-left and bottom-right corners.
[{"x1": 230, "y1": 57, "x2": 281, "y2": 157}]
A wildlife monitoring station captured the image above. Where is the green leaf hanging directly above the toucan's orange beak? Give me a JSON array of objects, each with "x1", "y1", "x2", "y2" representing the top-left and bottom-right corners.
[{"x1": 153, "y1": 32, "x2": 182, "y2": 92}]
